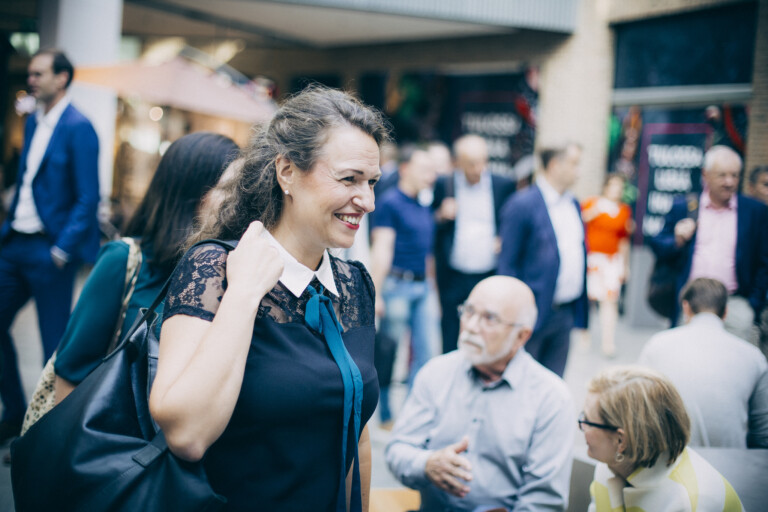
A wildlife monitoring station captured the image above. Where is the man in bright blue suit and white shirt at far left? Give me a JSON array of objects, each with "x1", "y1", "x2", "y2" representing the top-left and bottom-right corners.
[{"x1": 0, "y1": 50, "x2": 99, "y2": 443}]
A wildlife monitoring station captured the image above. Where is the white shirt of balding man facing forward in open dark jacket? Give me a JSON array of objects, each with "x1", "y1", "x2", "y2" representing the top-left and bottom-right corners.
[{"x1": 450, "y1": 172, "x2": 497, "y2": 274}]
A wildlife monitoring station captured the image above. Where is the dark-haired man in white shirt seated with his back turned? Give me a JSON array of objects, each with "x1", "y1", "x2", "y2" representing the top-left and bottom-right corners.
[{"x1": 638, "y1": 278, "x2": 768, "y2": 448}]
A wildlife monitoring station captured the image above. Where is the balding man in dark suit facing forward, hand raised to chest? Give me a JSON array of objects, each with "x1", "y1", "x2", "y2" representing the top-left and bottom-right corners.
[{"x1": 432, "y1": 135, "x2": 515, "y2": 353}]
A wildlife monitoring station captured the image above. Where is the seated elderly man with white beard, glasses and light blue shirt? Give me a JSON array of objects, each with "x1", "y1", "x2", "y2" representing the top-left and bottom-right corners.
[{"x1": 386, "y1": 276, "x2": 575, "y2": 512}]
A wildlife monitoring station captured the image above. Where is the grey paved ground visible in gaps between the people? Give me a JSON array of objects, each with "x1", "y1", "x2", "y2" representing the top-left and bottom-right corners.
[{"x1": 0, "y1": 279, "x2": 657, "y2": 512}]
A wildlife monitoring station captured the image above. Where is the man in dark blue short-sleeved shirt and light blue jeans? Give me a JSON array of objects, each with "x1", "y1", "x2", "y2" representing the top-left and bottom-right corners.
[{"x1": 371, "y1": 146, "x2": 435, "y2": 424}]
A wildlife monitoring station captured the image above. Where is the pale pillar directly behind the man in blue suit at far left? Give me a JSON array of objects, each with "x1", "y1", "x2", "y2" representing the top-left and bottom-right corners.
[{"x1": 39, "y1": 0, "x2": 123, "y2": 210}]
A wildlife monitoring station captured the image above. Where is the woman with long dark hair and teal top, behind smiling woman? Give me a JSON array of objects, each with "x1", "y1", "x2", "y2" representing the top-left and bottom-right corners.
[{"x1": 54, "y1": 132, "x2": 238, "y2": 403}]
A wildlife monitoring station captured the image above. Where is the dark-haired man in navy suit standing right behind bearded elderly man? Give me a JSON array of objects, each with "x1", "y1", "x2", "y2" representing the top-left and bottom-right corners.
[{"x1": 499, "y1": 143, "x2": 588, "y2": 377}]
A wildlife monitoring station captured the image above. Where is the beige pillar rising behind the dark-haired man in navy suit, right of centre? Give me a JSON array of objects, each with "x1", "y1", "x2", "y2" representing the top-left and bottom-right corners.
[{"x1": 536, "y1": 0, "x2": 613, "y2": 197}]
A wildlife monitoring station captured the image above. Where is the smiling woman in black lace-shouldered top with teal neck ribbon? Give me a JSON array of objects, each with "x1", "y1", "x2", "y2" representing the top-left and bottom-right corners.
[{"x1": 150, "y1": 88, "x2": 388, "y2": 512}]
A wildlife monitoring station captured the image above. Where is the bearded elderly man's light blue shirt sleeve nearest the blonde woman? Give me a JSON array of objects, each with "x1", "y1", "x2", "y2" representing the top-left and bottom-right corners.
[{"x1": 513, "y1": 395, "x2": 576, "y2": 512}]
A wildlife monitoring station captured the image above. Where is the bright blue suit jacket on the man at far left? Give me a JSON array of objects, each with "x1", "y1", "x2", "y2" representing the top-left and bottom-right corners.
[{"x1": 0, "y1": 105, "x2": 99, "y2": 262}]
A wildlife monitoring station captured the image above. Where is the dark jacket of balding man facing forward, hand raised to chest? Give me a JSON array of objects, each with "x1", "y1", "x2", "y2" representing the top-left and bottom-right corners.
[{"x1": 432, "y1": 174, "x2": 515, "y2": 280}]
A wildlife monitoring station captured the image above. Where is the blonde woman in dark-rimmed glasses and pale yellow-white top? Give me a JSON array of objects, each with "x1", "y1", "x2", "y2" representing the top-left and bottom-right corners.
[{"x1": 579, "y1": 366, "x2": 743, "y2": 512}]
